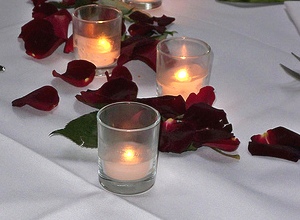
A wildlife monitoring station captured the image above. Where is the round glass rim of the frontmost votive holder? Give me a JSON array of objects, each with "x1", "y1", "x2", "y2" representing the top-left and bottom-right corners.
[{"x1": 97, "y1": 101, "x2": 161, "y2": 132}]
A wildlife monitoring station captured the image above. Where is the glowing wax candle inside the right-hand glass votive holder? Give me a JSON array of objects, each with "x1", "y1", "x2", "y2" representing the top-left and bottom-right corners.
[{"x1": 157, "y1": 64, "x2": 207, "y2": 99}]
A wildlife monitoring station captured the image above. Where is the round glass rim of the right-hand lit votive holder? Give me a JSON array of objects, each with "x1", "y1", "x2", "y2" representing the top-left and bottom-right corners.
[{"x1": 156, "y1": 36, "x2": 211, "y2": 59}]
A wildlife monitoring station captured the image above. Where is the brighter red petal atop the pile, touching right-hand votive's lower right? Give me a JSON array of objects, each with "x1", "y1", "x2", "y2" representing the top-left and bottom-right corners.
[{"x1": 186, "y1": 86, "x2": 216, "y2": 109}]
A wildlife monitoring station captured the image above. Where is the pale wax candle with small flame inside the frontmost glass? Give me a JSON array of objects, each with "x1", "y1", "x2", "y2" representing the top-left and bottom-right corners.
[{"x1": 101, "y1": 142, "x2": 153, "y2": 181}]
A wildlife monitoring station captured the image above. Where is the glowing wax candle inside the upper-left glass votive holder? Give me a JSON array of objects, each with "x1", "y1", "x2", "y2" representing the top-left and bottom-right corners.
[{"x1": 73, "y1": 34, "x2": 120, "y2": 67}]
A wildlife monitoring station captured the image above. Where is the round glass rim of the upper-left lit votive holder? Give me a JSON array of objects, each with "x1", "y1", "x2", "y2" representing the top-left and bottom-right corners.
[{"x1": 72, "y1": 4, "x2": 123, "y2": 24}]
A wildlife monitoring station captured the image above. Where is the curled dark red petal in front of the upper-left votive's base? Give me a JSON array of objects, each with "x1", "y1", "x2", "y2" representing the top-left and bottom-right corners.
[{"x1": 52, "y1": 60, "x2": 96, "y2": 87}]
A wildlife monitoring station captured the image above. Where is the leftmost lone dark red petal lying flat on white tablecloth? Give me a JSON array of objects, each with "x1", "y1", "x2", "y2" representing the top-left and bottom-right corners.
[{"x1": 12, "y1": 86, "x2": 59, "y2": 111}]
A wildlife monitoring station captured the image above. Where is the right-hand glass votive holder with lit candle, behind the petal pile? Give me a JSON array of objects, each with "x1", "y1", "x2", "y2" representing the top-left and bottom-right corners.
[{"x1": 156, "y1": 37, "x2": 212, "y2": 99}]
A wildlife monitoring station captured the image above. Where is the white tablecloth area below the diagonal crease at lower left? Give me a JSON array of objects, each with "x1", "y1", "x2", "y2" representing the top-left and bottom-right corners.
[{"x1": 0, "y1": 133, "x2": 162, "y2": 219}]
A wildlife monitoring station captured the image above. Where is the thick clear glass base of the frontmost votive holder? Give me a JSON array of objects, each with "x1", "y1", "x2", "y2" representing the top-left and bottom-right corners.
[{"x1": 99, "y1": 173, "x2": 155, "y2": 196}]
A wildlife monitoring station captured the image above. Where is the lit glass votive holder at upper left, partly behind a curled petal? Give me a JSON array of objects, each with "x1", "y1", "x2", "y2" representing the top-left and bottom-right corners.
[{"x1": 73, "y1": 4, "x2": 122, "y2": 75}]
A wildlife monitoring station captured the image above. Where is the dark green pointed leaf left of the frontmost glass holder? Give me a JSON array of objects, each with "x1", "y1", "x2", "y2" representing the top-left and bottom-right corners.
[{"x1": 50, "y1": 111, "x2": 97, "y2": 148}]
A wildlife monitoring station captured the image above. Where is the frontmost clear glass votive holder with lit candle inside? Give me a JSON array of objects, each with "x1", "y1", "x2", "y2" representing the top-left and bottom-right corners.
[{"x1": 97, "y1": 102, "x2": 161, "y2": 195}]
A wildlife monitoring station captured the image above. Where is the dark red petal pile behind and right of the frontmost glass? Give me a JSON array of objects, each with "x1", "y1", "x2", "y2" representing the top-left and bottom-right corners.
[{"x1": 76, "y1": 66, "x2": 240, "y2": 153}]
